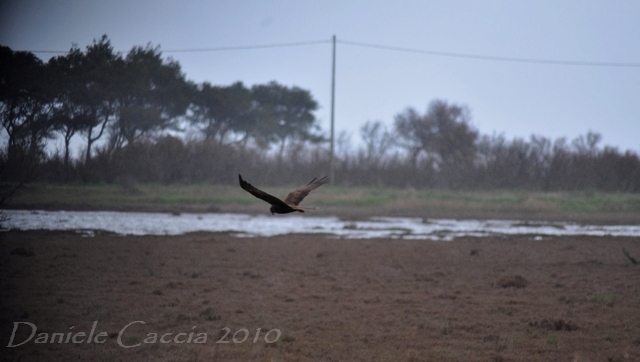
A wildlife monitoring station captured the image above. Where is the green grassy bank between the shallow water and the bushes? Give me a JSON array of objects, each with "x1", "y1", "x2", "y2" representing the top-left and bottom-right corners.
[{"x1": 4, "y1": 184, "x2": 640, "y2": 223}]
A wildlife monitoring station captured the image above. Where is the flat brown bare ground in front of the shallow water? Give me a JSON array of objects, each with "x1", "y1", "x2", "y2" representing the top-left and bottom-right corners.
[{"x1": 0, "y1": 231, "x2": 640, "y2": 361}]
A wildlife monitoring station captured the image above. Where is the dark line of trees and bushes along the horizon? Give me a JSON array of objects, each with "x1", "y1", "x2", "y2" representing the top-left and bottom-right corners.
[{"x1": 0, "y1": 36, "x2": 640, "y2": 192}]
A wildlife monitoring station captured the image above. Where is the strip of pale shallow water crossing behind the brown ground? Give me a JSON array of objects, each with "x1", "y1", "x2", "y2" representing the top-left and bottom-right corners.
[{"x1": 3, "y1": 210, "x2": 640, "y2": 240}]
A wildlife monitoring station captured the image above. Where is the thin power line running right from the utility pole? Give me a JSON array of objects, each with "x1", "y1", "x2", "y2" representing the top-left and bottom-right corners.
[{"x1": 338, "y1": 40, "x2": 640, "y2": 68}]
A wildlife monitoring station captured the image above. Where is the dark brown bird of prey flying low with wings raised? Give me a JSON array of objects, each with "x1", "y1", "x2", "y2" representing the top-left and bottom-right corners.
[{"x1": 238, "y1": 174, "x2": 329, "y2": 214}]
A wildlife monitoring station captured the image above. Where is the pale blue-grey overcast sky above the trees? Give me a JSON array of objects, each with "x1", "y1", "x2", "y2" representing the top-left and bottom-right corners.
[{"x1": 0, "y1": 0, "x2": 640, "y2": 152}]
